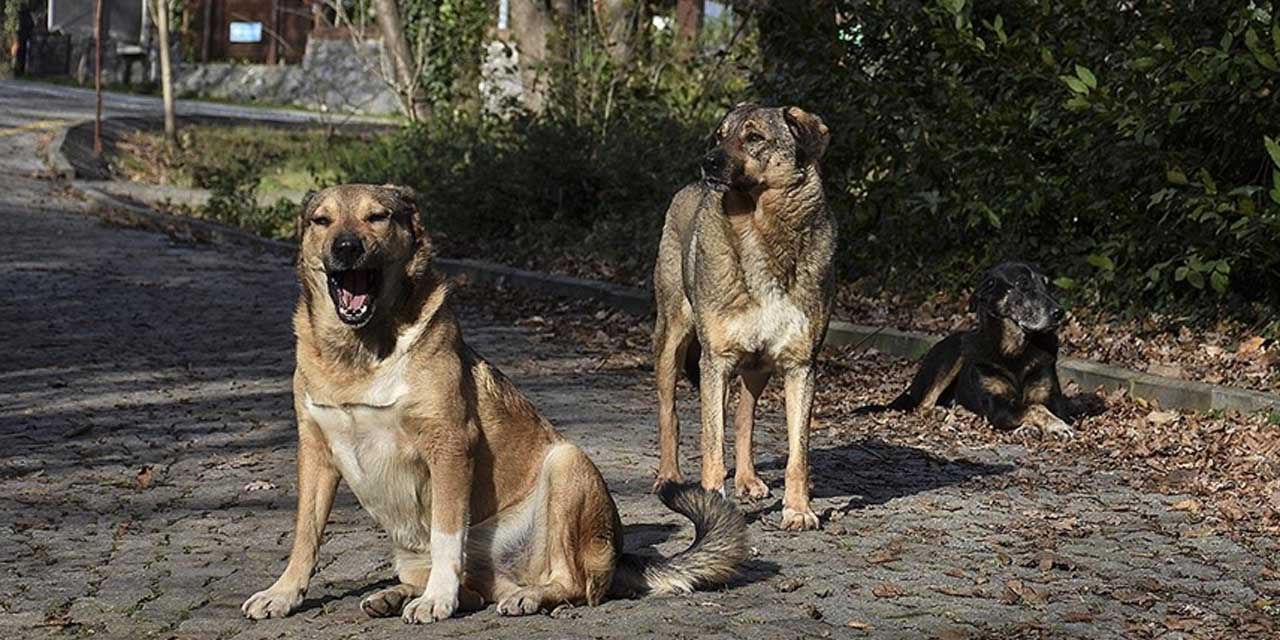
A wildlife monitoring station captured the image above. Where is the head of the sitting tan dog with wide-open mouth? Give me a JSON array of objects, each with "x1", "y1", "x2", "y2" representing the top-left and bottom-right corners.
[{"x1": 298, "y1": 184, "x2": 430, "y2": 329}]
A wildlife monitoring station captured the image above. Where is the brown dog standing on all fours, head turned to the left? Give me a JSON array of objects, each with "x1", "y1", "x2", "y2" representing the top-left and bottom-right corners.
[{"x1": 653, "y1": 105, "x2": 836, "y2": 530}]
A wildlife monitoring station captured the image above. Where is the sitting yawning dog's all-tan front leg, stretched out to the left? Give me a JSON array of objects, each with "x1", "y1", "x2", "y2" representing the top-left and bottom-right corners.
[{"x1": 241, "y1": 414, "x2": 338, "y2": 620}]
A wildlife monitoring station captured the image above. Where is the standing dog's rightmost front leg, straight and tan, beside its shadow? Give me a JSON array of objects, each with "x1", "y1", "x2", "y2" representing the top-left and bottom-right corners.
[{"x1": 781, "y1": 366, "x2": 818, "y2": 531}]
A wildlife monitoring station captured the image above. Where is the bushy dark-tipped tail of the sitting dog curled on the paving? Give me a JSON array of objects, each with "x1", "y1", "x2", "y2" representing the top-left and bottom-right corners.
[{"x1": 609, "y1": 483, "x2": 750, "y2": 598}]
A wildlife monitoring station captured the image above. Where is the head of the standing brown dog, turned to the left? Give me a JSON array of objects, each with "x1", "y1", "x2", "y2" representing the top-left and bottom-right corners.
[{"x1": 701, "y1": 104, "x2": 831, "y2": 192}]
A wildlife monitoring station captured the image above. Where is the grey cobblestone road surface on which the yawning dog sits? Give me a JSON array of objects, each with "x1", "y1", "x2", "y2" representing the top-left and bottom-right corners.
[{"x1": 0, "y1": 156, "x2": 1280, "y2": 639}]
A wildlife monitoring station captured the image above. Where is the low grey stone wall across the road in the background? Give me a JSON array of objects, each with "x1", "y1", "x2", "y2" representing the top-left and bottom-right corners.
[{"x1": 174, "y1": 37, "x2": 399, "y2": 115}]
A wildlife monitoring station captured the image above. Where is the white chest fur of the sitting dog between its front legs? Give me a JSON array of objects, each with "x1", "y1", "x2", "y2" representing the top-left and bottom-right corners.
[{"x1": 305, "y1": 397, "x2": 431, "y2": 552}]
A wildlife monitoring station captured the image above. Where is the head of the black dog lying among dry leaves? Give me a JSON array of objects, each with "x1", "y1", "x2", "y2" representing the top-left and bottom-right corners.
[{"x1": 969, "y1": 262, "x2": 1066, "y2": 333}]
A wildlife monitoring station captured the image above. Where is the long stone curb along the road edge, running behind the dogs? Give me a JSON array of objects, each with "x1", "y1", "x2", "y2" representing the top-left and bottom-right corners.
[{"x1": 57, "y1": 162, "x2": 1280, "y2": 412}]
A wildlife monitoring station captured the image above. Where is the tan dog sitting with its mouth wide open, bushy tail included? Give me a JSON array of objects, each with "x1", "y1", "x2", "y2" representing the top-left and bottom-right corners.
[{"x1": 243, "y1": 184, "x2": 748, "y2": 622}]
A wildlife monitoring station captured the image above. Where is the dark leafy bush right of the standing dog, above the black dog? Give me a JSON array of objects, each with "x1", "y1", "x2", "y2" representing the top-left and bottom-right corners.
[{"x1": 756, "y1": 0, "x2": 1280, "y2": 325}]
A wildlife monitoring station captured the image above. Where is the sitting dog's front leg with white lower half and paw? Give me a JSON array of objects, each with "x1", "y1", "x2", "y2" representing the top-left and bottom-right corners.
[{"x1": 401, "y1": 429, "x2": 472, "y2": 623}]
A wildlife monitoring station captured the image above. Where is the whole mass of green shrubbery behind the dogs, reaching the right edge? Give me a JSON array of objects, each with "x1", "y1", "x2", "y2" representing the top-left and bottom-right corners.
[{"x1": 320, "y1": 0, "x2": 1280, "y2": 333}]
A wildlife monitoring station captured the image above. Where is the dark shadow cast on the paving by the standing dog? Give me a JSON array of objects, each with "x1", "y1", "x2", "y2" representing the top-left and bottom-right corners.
[{"x1": 748, "y1": 438, "x2": 1014, "y2": 520}]
